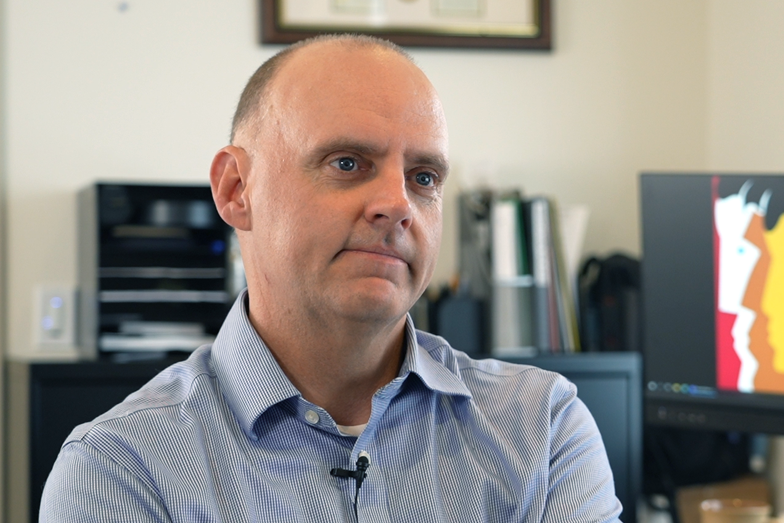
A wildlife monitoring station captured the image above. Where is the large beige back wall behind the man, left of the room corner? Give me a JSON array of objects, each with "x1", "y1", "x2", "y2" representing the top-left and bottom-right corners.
[{"x1": 3, "y1": 0, "x2": 712, "y2": 357}]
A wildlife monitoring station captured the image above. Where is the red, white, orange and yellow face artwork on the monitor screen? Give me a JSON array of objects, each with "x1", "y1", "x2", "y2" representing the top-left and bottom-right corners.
[{"x1": 711, "y1": 176, "x2": 784, "y2": 394}]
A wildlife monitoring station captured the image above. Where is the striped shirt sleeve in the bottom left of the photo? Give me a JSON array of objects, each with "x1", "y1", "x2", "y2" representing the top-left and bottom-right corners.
[{"x1": 38, "y1": 441, "x2": 171, "y2": 523}]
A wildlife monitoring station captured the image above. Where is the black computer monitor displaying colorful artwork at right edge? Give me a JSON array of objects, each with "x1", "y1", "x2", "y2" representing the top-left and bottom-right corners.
[{"x1": 640, "y1": 173, "x2": 784, "y2": 434}]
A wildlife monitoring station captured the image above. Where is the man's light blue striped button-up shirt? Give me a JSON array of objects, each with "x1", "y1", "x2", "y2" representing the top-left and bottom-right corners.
[{"x1": 40, "y1": 295, "x2": 621, "y2": 523}]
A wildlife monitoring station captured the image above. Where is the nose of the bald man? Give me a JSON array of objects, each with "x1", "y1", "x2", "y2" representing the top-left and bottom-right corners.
[{"x1": 365, "y1": 164, "x2": 412, "y2": 229}]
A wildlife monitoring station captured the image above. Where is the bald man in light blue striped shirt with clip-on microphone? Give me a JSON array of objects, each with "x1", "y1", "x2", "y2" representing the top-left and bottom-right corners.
[{"x1": 41, "y1": 36, "x2": 620, "y2": 523}]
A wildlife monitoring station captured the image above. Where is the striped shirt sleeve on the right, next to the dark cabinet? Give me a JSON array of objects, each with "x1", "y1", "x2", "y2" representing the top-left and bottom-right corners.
[{"x1": 542, "y1": 380, "x2": 621, "y2": 523}]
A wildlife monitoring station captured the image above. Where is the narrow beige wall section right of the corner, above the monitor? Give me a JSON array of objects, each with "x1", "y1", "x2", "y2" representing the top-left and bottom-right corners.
[{"x1": 707, "y1": 0, "x2": 784, "y2": 172}]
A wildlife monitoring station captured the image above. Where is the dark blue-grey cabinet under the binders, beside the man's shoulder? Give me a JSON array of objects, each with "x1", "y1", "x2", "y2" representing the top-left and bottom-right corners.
[{"x1": 503, "y1": 352, "x2": 642, "y2": 523}]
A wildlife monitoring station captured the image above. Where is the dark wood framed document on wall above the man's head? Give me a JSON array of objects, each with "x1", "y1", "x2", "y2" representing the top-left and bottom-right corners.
[{"x1": 259, "y1": 0, "x2": 552, "y2": 50}]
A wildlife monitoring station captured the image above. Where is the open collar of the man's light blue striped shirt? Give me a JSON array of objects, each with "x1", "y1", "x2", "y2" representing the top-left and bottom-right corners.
[{"x1": 212, "y1": 289, "x2": 471, "y2": 440}]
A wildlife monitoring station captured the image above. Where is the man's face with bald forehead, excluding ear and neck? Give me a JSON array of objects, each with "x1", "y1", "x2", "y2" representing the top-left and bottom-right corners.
[{"x1": 237, "y1": 44, "x2": 447, "y2": 324}]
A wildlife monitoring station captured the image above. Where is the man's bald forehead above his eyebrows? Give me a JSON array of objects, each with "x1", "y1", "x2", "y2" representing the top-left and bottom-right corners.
[{"x1": 264, "y1": 42, "x2": 447, "y2": 155}]
